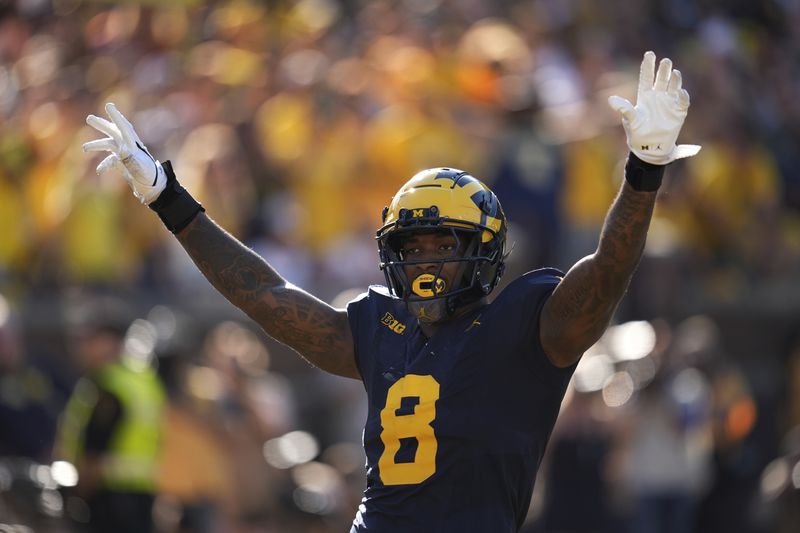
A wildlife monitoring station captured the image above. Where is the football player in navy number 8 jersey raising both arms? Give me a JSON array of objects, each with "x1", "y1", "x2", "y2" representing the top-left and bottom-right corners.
[{"x1": 84, "y1": 52, "x2": 700, "y2": 533}]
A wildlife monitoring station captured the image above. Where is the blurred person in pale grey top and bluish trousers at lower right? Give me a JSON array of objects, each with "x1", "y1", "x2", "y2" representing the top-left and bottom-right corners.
[{"x1": 622, "y1": 318, "x2": 716, "y2": 533}]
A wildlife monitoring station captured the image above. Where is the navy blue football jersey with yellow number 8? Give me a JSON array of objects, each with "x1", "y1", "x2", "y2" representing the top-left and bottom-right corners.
[{"x1": 347, "y1": 269, "x2": 574, "y2": 533}]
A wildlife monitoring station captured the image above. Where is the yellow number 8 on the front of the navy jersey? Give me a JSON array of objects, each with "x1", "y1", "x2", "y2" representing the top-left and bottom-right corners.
[{"x1": 378, "y1": 374, "x2": 439, "y2": 485}]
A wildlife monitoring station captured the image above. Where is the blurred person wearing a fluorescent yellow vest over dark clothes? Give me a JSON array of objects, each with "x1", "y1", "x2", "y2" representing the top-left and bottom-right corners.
[{"x1": 56, "y1": 302, "x2": 165, "y2": 533}]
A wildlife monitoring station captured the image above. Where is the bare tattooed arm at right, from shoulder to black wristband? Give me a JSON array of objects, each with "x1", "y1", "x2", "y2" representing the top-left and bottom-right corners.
[{"x1": 540, "y1": 183, "x2": 656, "y2": 366}]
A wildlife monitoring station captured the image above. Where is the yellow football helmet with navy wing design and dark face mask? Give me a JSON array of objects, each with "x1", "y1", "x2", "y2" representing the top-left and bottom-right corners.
[{"x1": 377, "y1": 168, "x2": 507, "y2": 322}]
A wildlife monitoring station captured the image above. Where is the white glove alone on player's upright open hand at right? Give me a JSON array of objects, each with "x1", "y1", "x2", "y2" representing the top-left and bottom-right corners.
[{"x1": 608, "y1": 52, "x2": 700, "y2": 165}]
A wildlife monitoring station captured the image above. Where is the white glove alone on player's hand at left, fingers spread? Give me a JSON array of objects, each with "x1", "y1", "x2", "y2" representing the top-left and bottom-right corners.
[{"x1": 83, "y1": 103, "x2": 167, "y2": 204}]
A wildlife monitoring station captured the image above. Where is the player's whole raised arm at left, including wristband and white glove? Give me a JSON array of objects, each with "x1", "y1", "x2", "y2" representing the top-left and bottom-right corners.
[{"x1": 84, "y1": 104, "x2": 360, "y2": 379}]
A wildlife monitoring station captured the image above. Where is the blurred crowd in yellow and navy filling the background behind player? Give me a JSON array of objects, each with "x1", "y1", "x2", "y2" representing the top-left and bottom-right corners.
[{"x1": 0, "y1": 0, "x2": 800, "y2": 533}]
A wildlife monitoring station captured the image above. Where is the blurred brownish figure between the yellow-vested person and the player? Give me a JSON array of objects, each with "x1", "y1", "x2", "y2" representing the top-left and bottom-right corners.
[{"x1": 200, "y1": 321, "x2": 300, "y2": 528}]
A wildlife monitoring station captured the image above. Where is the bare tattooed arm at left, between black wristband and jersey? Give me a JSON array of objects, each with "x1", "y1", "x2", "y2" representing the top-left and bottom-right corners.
[{"x1": 178, "y1": 213, "x2": 358, "y2": 377}]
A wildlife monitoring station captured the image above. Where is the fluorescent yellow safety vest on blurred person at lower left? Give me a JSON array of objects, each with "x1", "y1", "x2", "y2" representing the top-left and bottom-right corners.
[{"x1": 58, "y1": 363, "x2": 166, "y2": 492}]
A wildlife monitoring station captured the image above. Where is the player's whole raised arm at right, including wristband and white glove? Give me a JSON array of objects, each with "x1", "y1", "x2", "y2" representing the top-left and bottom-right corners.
[{"x1": 539, "y1": 52, "x2": 700, "y2": 367}]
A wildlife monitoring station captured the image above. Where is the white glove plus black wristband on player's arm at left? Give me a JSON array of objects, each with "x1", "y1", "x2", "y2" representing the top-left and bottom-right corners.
[{"x1": 83, "y1": 103, "x2": 205, "y2": 233}]
